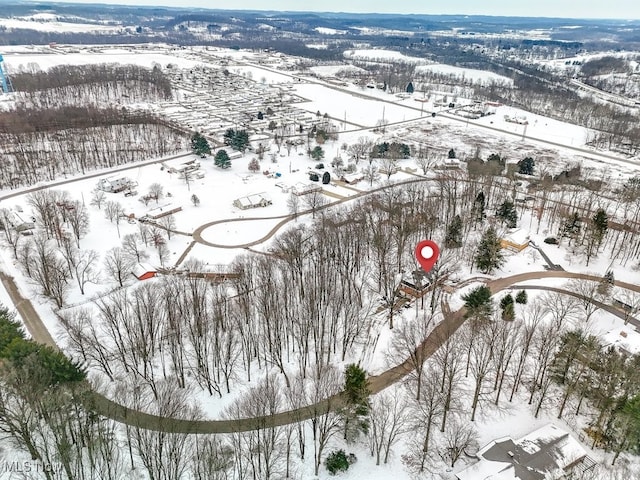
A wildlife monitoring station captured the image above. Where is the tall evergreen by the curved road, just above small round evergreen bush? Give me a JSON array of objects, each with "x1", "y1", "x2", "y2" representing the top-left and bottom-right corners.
[{"x1": 342, "y1": 363, "x2": 371, "y2": 442}]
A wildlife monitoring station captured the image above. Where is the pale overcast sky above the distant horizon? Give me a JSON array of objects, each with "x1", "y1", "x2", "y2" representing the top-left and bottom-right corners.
[{"x1": 48, "y1": 0, "x2": 640, "y2": 20}]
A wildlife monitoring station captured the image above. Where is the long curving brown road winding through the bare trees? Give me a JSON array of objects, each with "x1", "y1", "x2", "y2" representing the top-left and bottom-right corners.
[{"x1": 0, "y1": 271, "x2": 640, "y2": 434}]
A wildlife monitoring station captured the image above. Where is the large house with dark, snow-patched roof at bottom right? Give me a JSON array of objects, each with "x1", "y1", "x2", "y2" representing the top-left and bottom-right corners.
[{"x1": 456, "y1": 424, "x2": 595, "y2": 480}]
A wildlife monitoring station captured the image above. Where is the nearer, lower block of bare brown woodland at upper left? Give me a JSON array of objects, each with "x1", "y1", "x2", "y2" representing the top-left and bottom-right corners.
[{"x1": 0, "y1": 108, "x2": 186, "y2": 188}]
